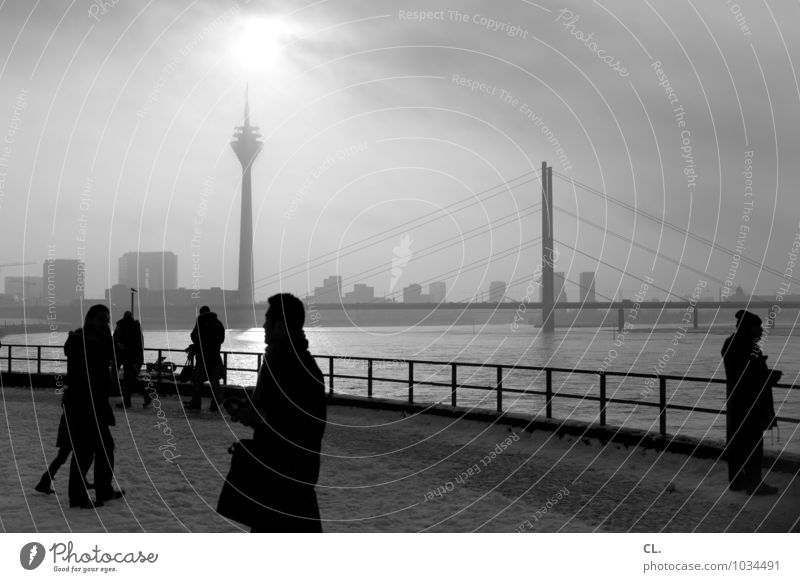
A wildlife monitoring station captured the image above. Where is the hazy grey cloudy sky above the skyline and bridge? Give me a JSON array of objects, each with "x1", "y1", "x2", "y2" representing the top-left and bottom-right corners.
[{"x1": 0, "y1": 0, "x2": 800, "y2": 300}]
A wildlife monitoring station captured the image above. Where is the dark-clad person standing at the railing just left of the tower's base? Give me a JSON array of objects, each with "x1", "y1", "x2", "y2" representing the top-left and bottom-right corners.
[{"x1": 185, "y1": 305, "x2": 225, "y2": 412}]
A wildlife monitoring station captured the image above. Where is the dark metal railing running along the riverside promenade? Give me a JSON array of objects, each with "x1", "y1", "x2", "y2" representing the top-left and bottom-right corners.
[{"x1": 3, "y1": 344, "x2": 800, "y2": 435}]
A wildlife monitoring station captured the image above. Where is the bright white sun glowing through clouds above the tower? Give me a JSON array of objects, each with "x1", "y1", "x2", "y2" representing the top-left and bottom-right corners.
[{"x1": 231, "y1": 17, "x2": 297, "y2": 72}]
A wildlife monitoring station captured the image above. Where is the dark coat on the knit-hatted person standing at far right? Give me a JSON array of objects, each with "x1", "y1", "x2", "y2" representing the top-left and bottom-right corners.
[{"x1": 722, "y1": 334, "x2": 777, "y2": 443}]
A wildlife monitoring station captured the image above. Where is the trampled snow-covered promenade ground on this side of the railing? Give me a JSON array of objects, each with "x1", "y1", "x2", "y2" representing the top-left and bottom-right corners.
[{"x1": 0, "y1": 387, "x2": 800, "y2": 532}]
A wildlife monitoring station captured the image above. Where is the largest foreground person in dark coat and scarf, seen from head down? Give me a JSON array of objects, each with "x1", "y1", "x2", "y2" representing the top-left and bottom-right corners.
[{"x1": 226, "y1": 293, "x2": 326, "y2": 532}]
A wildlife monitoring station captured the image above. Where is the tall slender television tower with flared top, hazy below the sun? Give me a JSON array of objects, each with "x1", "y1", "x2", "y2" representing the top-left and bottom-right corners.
[{"x1": 231, "y1": 87, "x2": 264, "y2": 305}]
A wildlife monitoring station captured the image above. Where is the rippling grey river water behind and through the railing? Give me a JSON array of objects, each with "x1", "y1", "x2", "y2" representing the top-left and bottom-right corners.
[{"x1": 0, "y1": 325, "x2": 800, "y2": 452}]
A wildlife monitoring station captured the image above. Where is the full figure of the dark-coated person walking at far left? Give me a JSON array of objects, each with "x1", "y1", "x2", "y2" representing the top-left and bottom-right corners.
[{"x1": 63, "y1": 305, "x2": 124, "y2": 509}]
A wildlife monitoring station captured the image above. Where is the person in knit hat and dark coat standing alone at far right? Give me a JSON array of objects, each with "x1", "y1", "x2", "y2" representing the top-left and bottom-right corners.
[{"x1": 722, "y1": 310, "x2": 782, "y2": 495}]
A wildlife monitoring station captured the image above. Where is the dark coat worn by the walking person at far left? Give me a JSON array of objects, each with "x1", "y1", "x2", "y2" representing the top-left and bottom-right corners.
[{"x1": 62, "y1": 329, "x2": 116, "y2": 434}]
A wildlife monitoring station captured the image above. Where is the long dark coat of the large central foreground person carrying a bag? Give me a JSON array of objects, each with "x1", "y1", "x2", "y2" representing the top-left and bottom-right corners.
[{"x1": 253, "y1": 339, "x2": 327, "y2": 527}]
